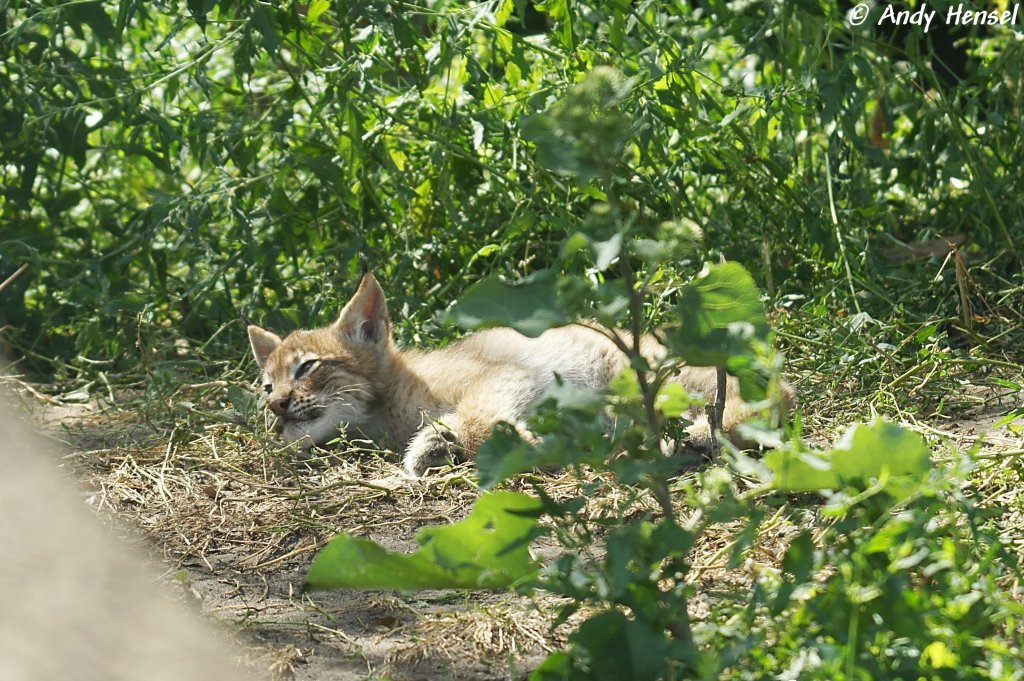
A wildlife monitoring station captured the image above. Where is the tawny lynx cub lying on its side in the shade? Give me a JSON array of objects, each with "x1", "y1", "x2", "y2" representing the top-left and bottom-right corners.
[{"x1": 249, "y1": 273, "x2": 774, "y2": 475}]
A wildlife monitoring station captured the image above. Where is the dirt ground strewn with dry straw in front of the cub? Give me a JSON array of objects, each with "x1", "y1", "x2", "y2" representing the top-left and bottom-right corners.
[{"x1": 8, "y1": 372, "x2": 1022, "y2": 681}]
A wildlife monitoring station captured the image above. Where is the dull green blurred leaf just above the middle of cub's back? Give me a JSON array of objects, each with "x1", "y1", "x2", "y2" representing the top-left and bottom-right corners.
[{"x1": 449, "y1": 269, "x2": 572, "y2": 337}]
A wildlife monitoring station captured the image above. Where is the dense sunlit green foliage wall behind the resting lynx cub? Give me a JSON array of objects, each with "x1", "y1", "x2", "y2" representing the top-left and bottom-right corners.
[{"x1": 0, "y1": 0, "x2": 1024, "y2": 387}]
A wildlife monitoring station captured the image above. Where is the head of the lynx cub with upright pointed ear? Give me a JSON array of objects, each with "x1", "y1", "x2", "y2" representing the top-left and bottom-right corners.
[{"x1": 249, "y1": 272, "x2": 391, "y2": 450}]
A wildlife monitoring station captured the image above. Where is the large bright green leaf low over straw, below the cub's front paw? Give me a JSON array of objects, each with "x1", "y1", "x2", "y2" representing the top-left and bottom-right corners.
[{"x1": 303, "y1": 492, "x2": 540, "y2": 591}]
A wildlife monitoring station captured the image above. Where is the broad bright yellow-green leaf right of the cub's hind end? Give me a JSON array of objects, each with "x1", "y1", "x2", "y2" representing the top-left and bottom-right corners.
[{"x1": 764, "y1": 419, "x2": 931, "y2": 502}]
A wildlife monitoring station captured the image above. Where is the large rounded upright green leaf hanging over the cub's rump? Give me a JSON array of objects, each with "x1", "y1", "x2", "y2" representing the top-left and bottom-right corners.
[{"x1": 666, "y1": 262, "x2": 768, "y2": 367}]
